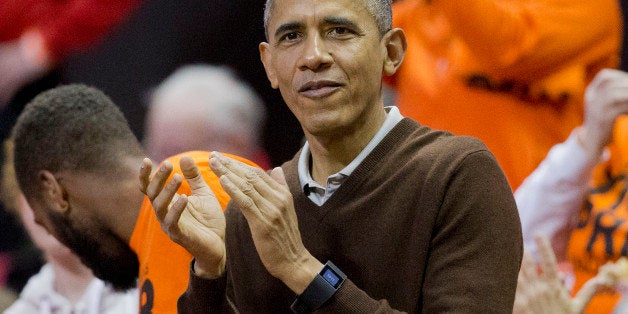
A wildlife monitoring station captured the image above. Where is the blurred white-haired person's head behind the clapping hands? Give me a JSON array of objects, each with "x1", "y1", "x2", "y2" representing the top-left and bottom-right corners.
[{"x1": 144, "y1": 64, "x2": 270, "y2": 169}]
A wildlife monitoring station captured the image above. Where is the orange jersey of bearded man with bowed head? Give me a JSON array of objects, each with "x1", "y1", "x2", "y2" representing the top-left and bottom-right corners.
[{"x1": 130, "y1": 151, "x2": 257, "y2": 314}]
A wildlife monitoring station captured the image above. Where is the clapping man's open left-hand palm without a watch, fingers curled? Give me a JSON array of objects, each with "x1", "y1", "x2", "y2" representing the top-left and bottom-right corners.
[{"x1": 139, "y1": 156, "x2": 226, "y2": 278}]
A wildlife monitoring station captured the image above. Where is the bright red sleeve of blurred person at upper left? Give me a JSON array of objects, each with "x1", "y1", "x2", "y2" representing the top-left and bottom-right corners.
[{"x1": 33, "y1": 0, "x2": 140, "y2": 60}]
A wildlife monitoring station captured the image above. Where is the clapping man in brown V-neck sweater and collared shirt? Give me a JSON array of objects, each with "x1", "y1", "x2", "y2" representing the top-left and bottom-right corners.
[{"x1": 140, "y1": 0, "x2": 522, "y2": 313}]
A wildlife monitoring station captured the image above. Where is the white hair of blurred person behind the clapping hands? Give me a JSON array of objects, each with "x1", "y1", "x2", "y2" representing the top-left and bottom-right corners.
[{"x1": 145, "y1": 64, "x2": 266, "y2": 162}]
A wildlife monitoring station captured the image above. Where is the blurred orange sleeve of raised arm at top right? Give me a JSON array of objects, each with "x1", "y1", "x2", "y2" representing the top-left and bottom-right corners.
[{"x1": 432, "y1": 0, "x2": 621, "y2": 79}]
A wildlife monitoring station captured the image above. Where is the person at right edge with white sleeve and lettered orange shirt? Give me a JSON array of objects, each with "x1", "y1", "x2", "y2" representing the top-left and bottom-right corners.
[{"x1": 515, "y1": 70, "x2": 628, "y2": 313}]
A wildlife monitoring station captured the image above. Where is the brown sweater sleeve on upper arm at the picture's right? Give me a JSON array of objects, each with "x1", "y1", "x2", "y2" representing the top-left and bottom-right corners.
[{"x1": 422, "y1": 150, "x2": 523, "y2": 313}]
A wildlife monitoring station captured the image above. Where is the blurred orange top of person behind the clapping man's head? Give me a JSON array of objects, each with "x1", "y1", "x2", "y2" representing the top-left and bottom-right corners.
[{"x1": 386, "y1": 0, "x2": 621, "y2": 190}]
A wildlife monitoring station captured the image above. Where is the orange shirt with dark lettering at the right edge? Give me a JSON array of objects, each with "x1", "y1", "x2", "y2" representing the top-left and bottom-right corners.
[{"x1": 567, "y1": 116, "x2": 628, "y2": 313}]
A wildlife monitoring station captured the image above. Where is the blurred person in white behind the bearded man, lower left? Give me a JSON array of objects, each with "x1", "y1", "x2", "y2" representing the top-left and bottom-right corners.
[{"x1": 2, "y1": 141, "x2": 139, "y2": 314}]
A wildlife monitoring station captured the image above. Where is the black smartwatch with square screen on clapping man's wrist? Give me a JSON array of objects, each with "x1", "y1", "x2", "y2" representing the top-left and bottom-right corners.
[{"x1": 290, "y1": 261, "x2": 347, "y2": 313}]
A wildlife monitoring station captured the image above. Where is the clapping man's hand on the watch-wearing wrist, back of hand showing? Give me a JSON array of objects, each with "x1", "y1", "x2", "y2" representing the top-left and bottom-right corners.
[{"x1": 210, "y1": 152, "x2": 323, "y2": 294}]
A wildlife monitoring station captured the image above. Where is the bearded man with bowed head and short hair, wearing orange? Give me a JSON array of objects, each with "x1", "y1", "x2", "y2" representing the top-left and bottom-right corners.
[{"x1": 12, "y1": 85, "x2": 260, "y2": 313}]
